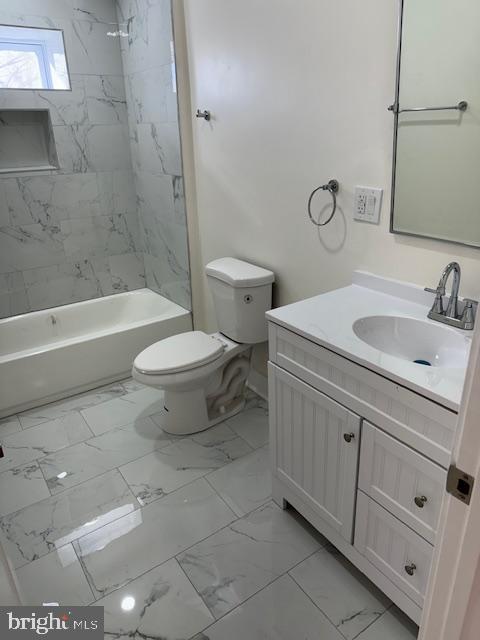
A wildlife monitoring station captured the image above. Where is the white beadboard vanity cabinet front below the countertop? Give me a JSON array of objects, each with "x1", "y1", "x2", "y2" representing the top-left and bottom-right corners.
[{"x1": 269, "y1": 321, "x2": 457, "y2": 622}]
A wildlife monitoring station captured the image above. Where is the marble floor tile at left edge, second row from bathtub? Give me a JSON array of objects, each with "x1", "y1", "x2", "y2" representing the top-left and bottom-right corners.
[{"x1": 0, "y1": 412, "x2": 93, "y2": 472}]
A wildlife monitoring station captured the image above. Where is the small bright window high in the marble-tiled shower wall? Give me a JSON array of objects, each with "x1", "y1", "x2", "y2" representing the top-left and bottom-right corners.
[{"x1": 0, "y1": 25, "x2": 70, "y2": 91}]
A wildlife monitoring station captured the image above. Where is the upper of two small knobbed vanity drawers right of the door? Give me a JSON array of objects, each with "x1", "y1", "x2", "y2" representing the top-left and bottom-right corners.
[{"x1": 358, "y1": 421, "x2": 447, "y2": 544}]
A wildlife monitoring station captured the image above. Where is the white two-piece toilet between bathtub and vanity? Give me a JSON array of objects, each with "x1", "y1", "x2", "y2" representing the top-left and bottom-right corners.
[{"x1": 132, "y1": 258, "x2": 275, "y2": 435}]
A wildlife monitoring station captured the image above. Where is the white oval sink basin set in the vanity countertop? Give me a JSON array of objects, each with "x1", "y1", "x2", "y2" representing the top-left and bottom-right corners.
[{"x1": 352, "y1": 316, "x2": 471, "y2": 369}]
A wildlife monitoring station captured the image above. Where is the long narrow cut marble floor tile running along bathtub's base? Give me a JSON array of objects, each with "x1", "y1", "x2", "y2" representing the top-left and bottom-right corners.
[{"x1": 18, "y1": 383, "x2": 125, "y2": 429}]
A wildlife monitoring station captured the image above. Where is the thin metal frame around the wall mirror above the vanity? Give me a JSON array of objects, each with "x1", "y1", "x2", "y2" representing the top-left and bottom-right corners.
[{"x1": 388, "y1": 0, "x2": 480, "y2": 249}]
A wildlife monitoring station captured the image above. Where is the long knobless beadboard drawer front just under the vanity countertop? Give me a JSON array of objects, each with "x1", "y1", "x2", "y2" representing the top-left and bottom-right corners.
[{"x1": 269, "y1": 322, "x2": 457, "y2": 469}]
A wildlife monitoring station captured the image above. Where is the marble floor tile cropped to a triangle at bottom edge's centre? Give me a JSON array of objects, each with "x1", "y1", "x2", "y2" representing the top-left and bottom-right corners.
[{"x1": 189, "y1": 576, "x2": 344, "y2": 640}]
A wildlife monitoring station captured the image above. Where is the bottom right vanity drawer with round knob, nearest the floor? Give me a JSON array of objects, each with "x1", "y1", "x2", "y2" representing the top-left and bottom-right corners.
[{"x1": 355, "y1": 491, "x2": 433, "y2": 607}]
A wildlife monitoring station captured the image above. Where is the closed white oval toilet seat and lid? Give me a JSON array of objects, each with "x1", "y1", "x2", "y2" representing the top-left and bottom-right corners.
[{"x1": 133, "y1": 331, "x2": 226, "y2": 375}]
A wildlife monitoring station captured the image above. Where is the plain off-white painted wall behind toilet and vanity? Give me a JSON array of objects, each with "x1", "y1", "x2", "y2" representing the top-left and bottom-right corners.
[{"x1": 175, "y1": 0, "x2": 480, "y2": 350}]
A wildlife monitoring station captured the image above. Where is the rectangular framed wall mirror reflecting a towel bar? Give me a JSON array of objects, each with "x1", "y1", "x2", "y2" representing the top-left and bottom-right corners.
[{"x1": 390, "y1": 0, "x2": 480, "y2": 247}]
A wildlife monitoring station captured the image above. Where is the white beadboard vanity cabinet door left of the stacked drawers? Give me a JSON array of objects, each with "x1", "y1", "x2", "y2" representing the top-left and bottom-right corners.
[{"x1": 269, "y1": 363, "x2": 361, "y2": 542}]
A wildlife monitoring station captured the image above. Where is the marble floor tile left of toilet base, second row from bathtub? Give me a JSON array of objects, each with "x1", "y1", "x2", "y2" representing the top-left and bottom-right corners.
[{"x1": 82, "y1": 387, "x2": 163, "y2": 435}]
